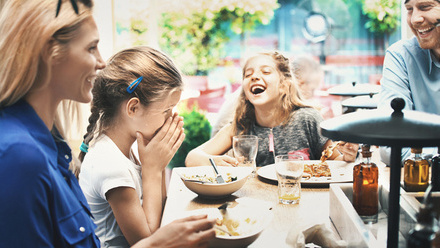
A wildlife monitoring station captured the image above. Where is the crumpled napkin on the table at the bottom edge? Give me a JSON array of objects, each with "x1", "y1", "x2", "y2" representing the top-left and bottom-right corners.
[{"x1": 286, "y1": 224, "x2": 347, "y2": 248}]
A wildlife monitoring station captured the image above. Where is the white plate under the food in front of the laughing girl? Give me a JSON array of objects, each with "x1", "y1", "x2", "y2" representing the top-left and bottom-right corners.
[{"x1": 257, "y1": 160, "x2": 354, "y2": 186}]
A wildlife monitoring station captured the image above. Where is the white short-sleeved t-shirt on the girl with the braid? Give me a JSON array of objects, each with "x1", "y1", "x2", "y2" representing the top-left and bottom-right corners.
[{"x1": 79, "y1": 135, "x2": 142, "y2": 247}]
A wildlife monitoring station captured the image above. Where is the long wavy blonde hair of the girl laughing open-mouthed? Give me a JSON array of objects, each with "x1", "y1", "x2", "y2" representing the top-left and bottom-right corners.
[{"x1": 232, "y1": 51, "x2": 310, "y2": 134}]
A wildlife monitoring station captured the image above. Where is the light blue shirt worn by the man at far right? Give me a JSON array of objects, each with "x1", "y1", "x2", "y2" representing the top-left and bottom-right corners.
[{"x1": 378, "y1": 37, "x2": 440, "y2": 164}]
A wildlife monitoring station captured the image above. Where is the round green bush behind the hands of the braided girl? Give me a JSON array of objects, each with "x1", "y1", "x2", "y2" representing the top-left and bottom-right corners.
[{"x1": 169, "y1": 104, "x2": 211, "y2": 167}]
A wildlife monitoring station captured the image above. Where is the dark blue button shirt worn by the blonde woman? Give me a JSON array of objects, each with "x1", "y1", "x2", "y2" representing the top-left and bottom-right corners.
[{"x1": 0, "y1": 101, "x2": 100, "y2": 247}]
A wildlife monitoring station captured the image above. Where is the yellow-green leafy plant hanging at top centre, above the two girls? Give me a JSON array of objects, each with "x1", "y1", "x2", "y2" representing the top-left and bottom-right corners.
[{"x1": 160, "y1": 0, "x2": 279, "y2": 75}]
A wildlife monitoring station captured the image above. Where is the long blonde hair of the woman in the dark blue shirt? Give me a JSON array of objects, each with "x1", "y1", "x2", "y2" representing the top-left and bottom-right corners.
[{"x1": 0, "y1": 0, "x2": 93, "y2": 176}]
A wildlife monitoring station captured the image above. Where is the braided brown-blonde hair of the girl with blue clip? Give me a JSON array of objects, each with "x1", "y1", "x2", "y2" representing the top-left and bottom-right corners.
[{"x1": 79, "y1": 46, "x2": 183, "y2": 161}]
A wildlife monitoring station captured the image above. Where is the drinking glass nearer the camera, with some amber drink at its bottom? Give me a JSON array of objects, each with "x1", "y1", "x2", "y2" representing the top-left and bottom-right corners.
[{"x1": 275, "y1": 155, "x2": 304, "y2": 204}]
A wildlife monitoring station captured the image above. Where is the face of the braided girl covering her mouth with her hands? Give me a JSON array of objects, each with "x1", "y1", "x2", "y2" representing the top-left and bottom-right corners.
[{"x1": 137, "y1": 91, "x2": 182, "y2": 140}]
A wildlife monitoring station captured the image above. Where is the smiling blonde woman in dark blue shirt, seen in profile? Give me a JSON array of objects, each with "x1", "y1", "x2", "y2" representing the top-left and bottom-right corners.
[{"x1": 0, "y1": 0, "x2": 214, "y2": 247}]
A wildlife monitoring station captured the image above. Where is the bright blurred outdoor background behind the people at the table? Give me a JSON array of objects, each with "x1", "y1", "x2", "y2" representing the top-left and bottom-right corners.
[{"x1": 0, "y1": 0, "x2": 411, "y2": 167}]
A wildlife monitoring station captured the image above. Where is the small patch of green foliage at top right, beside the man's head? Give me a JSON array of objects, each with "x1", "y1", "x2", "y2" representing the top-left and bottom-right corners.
[{"x1": 361, "y1": 0, "x2": 401, "y2": 34}]
